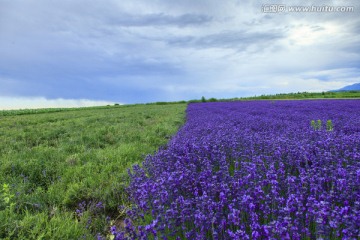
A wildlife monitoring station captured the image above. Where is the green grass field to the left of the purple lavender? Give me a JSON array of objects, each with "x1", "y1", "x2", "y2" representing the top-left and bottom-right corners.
[{"x1": 0, "y1": 103, "x2": 186, "y2": 239}]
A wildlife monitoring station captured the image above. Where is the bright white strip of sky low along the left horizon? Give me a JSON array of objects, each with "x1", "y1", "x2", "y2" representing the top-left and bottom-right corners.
[{"x1": 0, "y1": 96, "x2": 114, "y2": 110}]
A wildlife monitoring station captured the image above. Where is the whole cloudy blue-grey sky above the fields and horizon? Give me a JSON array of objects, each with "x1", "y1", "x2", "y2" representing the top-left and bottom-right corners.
[{"x1": 0, "y1": 0, "x2": 360, "y2": 109}]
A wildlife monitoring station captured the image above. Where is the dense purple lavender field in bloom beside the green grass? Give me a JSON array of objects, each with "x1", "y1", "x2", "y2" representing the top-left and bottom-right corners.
[{"x1": 112, "y1": 100, "x2": 360, "y2": 239}]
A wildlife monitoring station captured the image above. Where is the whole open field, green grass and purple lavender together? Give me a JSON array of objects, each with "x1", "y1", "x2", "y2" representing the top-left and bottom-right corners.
[{"x1": 0, "y1": 98, "x2": 360, "y2": 239}]
